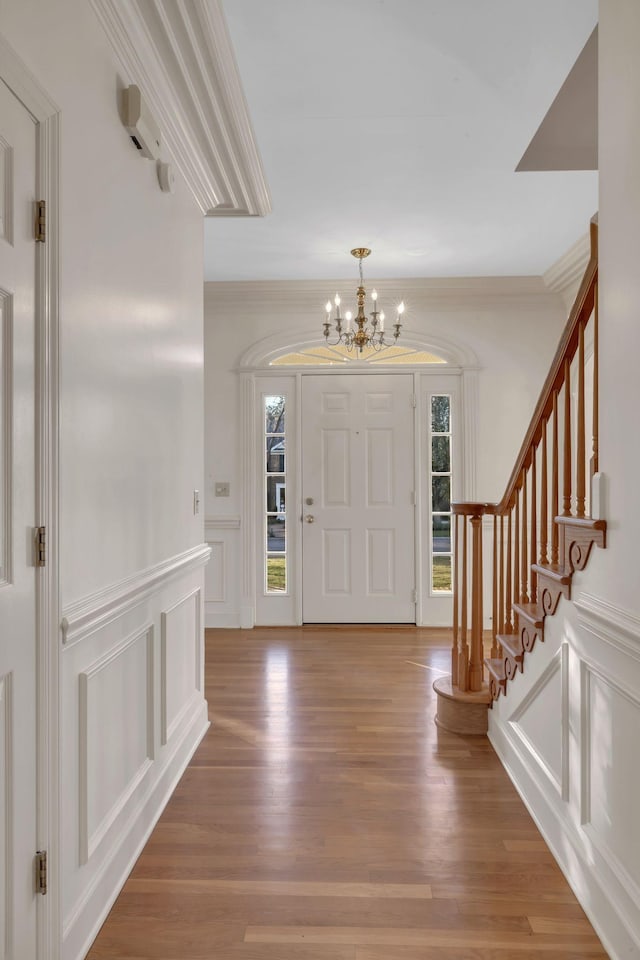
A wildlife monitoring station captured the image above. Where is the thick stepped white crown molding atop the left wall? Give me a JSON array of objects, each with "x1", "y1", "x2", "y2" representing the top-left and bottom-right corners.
[{"x1": 91, "y1": 0, "x2": 271, "y2": 217}]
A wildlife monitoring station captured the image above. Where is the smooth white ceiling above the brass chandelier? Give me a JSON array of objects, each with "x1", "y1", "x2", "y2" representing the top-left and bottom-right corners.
[{"x1": 205, "y1": 0, "x2": 598, "y2": 280}]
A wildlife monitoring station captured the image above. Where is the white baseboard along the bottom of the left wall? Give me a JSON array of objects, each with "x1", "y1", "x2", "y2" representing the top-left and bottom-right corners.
[{"x1": 62, "y1": 700, "x2": 210, "y2": 960}]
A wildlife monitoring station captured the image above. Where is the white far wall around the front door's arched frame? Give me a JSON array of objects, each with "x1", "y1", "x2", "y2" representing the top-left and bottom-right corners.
[{"x1": 205, "y1": 278, "x2": 566, "y2": 625}]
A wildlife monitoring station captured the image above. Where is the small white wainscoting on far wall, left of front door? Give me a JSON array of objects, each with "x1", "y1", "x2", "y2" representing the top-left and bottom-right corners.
[{"x1": 204, "y1": 516, "x2": 241, "y2": 627}]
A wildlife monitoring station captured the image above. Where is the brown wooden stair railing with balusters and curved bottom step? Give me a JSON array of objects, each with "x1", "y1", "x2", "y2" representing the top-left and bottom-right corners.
[{"x1": 434, "y1": 223, "x2": 606, "y2": 733}]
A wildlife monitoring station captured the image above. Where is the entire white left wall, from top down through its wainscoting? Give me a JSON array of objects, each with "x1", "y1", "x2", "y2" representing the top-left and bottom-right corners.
[{"x1": 0, "y1": 0, "x2": 207, "y2": 960}]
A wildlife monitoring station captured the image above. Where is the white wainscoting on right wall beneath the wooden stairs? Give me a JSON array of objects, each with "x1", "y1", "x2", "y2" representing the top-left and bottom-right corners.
[{"x1": 489, "y1": 592, "x2": 640, "y2": 960}]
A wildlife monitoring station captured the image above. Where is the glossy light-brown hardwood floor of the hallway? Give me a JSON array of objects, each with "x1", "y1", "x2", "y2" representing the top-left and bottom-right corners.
[{"x1": 88, "y1": 627, "x2": 607, "y2": 960}]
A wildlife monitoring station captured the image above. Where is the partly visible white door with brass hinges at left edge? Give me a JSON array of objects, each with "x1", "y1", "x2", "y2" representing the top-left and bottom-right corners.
[{"x1": 0, "y1": 83, "x2": 37, "y2": 960}]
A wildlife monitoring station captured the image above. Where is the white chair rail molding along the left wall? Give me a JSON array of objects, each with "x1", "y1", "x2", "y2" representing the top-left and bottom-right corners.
[{"x1": 61, "y1": 543, "x2": 211, "y2": 647}]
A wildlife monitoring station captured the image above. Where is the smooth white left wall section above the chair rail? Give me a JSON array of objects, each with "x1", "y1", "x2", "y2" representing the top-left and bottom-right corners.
[{"x1": 0, "y1": 0, "x2": 202, "y2": 604}]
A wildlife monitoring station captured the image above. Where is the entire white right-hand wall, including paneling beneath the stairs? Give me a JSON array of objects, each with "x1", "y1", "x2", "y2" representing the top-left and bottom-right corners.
[{"x1": 490, "y1": 7, "x2": 640, "y2": 960}]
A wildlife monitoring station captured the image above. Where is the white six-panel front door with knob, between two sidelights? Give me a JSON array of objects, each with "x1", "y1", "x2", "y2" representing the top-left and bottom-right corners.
[{"x1": 302, "y1": 374, "x2": 416, "y2": 623}]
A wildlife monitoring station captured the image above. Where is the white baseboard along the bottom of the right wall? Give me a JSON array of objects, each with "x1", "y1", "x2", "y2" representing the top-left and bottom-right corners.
[{"x1": 489, "y1": 716, "x2": 640, "y2": 960}]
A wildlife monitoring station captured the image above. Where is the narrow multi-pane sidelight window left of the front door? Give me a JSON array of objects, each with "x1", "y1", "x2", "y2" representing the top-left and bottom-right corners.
[{"x1": 263, "y1": 396, "x2": 287, "y2": 593}]
